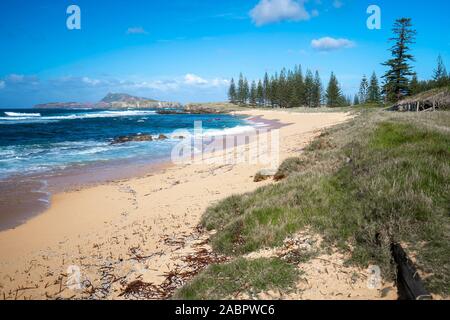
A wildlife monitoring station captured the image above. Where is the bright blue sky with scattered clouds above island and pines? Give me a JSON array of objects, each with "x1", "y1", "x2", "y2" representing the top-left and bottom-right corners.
[{"x1": 0, "y1": 0, "x2": 450, "y2": 107}]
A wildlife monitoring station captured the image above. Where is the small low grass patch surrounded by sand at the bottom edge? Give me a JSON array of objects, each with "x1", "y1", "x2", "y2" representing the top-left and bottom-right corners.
[{"x1": 174, "y1": 258, "x2": 298, "y2": 300}]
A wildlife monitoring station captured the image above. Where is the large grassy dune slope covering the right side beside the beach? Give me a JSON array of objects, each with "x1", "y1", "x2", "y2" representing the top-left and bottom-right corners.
[{"x1": 203, "y1": 110, "x2": 450, "y2": 295}]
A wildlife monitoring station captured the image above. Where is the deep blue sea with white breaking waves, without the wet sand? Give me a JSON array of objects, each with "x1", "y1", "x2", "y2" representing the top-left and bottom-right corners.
[{"x1": 0, "y1": 109, "x2": 249, "y2": 180}]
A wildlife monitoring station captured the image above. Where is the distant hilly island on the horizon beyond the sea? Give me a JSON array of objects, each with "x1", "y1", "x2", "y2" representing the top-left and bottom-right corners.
[{"x1": 34, "y1": 93, "x2": 182, "y2": 109}]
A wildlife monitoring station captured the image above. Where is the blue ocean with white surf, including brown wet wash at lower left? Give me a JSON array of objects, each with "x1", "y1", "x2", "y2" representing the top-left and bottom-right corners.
[{"x1": 0, "y1": 109, "x2": 250, "y2": 230}]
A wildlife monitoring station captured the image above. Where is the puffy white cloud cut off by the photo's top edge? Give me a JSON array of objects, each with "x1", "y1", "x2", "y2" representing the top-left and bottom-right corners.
[{"x1": 250, "y1": 0, "x2": 311, "y2": 26}]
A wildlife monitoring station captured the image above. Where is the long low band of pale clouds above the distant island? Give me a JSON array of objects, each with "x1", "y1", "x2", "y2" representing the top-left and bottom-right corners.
[{"x1": 0, "y1": 73, "x2": 229, "y2": 105}]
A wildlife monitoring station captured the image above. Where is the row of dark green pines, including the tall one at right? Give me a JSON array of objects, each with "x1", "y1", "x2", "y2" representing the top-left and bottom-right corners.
[{"x1": 228, "y1": 18, "x2": 450, "y2": 108}]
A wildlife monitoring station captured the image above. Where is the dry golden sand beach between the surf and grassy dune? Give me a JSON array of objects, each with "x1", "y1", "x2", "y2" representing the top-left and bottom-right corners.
[{"x1": 0, "y1": 110, "x2": 398, "y2": 299}]
